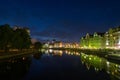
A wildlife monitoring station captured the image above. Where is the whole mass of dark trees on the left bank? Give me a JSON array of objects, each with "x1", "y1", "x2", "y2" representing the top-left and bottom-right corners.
[{"x1": 0, "y1": 24, "x2": 31, "y2": 51}]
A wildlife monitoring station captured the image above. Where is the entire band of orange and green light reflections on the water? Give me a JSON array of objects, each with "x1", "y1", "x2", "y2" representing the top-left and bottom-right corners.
[{"x1": 40, "y1": 49, "x2": 120, "y2": 80}]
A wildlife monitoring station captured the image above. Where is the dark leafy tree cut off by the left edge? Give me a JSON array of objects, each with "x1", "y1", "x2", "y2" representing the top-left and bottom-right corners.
[{"x1": 0, "y1": 24, "x2": 13, "y2": 51}]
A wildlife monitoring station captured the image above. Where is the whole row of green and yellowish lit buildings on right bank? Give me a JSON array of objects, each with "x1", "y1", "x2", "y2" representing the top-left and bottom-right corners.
[{"x1": 80, "y1": 27, "x2": 120, "y2": 49}]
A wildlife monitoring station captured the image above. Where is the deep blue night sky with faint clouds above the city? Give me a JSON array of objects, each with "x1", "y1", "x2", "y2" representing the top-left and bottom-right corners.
[{"x1": 0, "y1": 0, "x2": 120, "y2": 42}]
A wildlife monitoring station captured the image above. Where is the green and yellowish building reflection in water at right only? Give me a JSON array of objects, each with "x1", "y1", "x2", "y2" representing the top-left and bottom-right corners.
[{"x1": 81, "y1": 53, "x2": 120, "y2": 80}]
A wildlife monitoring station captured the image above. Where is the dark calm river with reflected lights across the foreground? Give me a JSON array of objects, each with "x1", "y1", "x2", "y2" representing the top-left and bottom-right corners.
[{"x1": 0, "y1": 50, "x2": 120, "y2": 80}]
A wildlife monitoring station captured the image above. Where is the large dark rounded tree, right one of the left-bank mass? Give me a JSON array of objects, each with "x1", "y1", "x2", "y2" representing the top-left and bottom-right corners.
[{"x1": 13, "y1": 29, "x2": 31, "y2": 49}]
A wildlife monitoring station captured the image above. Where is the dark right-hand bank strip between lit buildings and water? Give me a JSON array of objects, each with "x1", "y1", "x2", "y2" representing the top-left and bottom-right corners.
[{"x1": 49, "y1": 48, "x2": 120, "y2": 60}]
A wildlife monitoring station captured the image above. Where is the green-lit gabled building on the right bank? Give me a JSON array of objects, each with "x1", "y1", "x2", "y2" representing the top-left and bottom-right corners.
[{"x1": 80, "y1": 32, "x2": 105, "y2": 49}]
